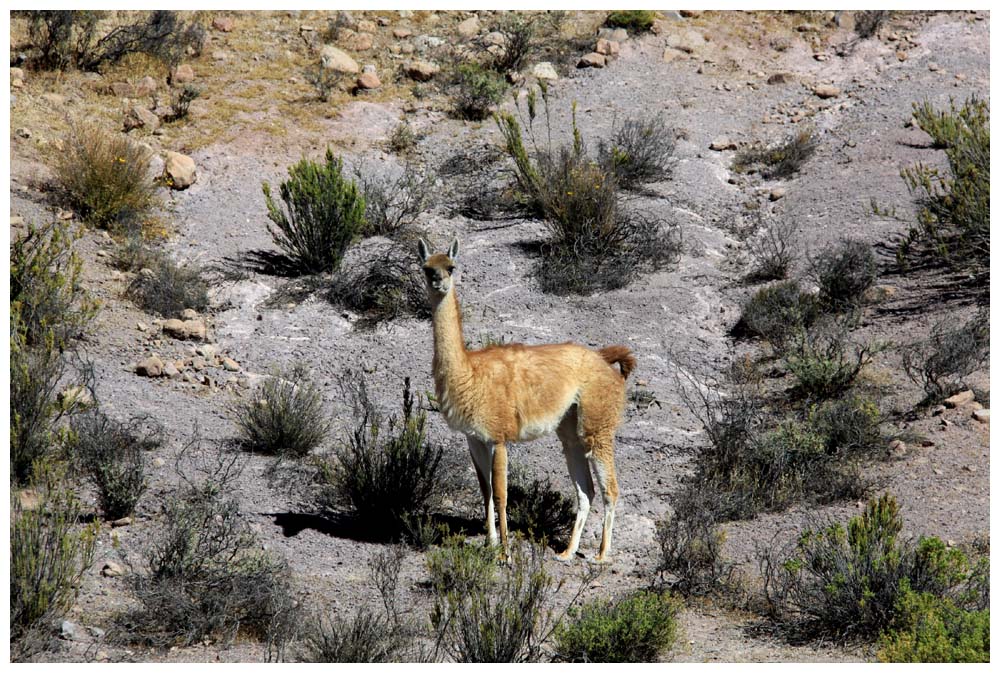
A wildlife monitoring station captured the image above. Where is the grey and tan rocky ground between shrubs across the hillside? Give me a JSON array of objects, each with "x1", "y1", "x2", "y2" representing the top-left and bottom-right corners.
[{"x1": 10, "y1": 12, "x2": 990, "y2": 661}]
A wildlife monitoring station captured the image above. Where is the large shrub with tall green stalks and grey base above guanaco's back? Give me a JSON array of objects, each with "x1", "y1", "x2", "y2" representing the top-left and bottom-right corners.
[{"x1": 497, "y1": 95, "x2": 680, "y2": 294}]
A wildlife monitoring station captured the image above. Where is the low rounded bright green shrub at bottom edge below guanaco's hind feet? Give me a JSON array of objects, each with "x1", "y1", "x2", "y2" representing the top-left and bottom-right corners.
[{"x1": 555, "y1": 591, "x2": 681, "y2": 663}]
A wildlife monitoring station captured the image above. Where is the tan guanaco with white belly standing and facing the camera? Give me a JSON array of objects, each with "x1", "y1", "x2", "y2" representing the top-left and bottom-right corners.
[{"x1": 420, "y1": 240, "x2": 635, "y2": 560}]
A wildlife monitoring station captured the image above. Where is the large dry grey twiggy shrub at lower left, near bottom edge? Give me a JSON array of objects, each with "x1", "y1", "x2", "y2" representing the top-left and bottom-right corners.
[{"x1": 117, "y1": 443, "x2": 298, "y2": 657}]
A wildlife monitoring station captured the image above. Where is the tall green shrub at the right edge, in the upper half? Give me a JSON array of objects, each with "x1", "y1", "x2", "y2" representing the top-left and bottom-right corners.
[{"x1": 897, "y1": 97, "x2": 990, "y2": 286}]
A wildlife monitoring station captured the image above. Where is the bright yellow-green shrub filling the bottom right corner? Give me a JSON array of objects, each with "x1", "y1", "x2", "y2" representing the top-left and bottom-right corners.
[{"x1": 878, "y1": 580, "x2": 990, "y2": 663}]
